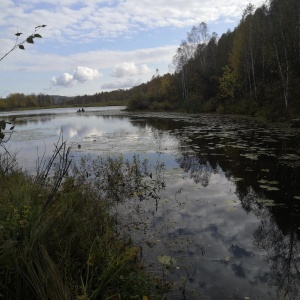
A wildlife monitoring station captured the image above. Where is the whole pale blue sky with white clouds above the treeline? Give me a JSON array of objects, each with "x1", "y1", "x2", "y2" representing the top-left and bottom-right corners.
[{"x1": 0, "y1": 0, "x2": 264, "y2": 98}]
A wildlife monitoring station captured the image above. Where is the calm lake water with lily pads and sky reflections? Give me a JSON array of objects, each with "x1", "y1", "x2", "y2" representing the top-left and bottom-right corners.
[{"x1": 0, "y1": 107, "x2": 300, "y2": 299}]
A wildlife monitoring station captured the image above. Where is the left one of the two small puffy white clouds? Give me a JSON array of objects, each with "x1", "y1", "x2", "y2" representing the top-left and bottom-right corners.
[{"x1": 51, "y1": 66, "x2": 100, "y2": 87}]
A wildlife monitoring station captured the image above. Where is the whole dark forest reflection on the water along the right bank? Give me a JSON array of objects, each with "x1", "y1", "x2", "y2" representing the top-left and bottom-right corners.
[{"x1": 138, "y1": 115, "x2": 300, "y2": 299}]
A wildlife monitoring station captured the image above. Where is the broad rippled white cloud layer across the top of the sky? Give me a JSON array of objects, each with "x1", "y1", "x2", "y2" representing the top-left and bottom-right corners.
[{"x1": 0, "y1": 0, "x2": 263, "y2": 43}]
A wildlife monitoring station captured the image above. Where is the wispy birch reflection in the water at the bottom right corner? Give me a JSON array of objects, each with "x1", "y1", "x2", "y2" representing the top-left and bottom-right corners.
[{"x1": 242, "y1": 188, "x2": 300, "y2": 299}]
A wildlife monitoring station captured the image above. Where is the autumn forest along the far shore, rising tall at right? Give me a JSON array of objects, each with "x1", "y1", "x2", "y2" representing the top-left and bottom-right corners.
[{"x1": 0, "y1": 0, "x2": 300, "y2": 120}]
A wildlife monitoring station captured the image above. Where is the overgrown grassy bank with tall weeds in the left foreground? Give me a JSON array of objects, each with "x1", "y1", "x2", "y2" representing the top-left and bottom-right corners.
[{"x1": 0, "y1": 143, "x2": 166, "y2": 300}]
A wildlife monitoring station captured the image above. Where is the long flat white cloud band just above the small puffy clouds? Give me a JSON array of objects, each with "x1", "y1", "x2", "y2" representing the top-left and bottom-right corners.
[{"x1": 1, "y1": 44, "x2": 178, "y2": 77}]
